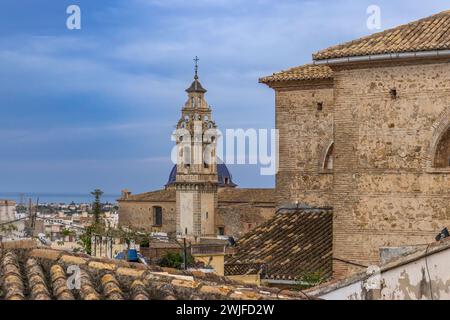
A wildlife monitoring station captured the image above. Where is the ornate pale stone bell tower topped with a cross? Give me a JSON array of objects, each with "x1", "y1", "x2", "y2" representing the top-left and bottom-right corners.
[{"x1": 175, "y1": 57, "x2": 218, "y2": 238}]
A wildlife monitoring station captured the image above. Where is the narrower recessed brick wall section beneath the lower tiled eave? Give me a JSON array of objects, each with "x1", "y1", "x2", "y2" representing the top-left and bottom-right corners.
[{"x1": 276, "y1": 81, "x2": 334, "y2": 206}]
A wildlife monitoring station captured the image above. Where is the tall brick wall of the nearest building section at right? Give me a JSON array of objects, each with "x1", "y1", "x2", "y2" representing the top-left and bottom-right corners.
[{"x1": 333, "y1": 63, "x2": 450, "y2": 275}]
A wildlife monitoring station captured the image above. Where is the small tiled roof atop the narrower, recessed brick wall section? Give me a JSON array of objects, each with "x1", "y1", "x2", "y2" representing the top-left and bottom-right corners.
[{"x1": 259, "y1": 64, "x2": 333, "y2": 84}]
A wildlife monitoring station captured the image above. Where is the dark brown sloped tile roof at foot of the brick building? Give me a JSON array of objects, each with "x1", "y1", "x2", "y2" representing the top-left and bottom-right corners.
[{"x1": 225, "y1": 209, "x2": 333, "y2": 280}]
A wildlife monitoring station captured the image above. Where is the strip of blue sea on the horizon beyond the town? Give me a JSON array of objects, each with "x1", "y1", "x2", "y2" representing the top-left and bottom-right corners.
[{"x1": 0, "y1": 192, "x2": 120, "y2": 204}]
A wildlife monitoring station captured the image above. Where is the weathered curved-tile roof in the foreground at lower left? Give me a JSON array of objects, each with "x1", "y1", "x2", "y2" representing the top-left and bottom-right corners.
[{"x1": 0, "y1": 248, "x2": 307, "y2": 300}]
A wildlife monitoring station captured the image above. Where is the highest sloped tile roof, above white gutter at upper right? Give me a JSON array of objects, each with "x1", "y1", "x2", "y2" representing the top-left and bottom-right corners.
[{"x1": 313, "y1": 11, "x2": 450, "y2": 60}]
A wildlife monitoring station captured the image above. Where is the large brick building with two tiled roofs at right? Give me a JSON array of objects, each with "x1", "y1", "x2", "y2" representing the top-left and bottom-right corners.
[{"x1": 260, "y1": 11, "x2": 450, "y2": 276}]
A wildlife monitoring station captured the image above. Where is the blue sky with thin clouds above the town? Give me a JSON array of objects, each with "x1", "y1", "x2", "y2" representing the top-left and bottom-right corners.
[{"x1": 0, "y1": 0, "x2": 450, "y2": 193}]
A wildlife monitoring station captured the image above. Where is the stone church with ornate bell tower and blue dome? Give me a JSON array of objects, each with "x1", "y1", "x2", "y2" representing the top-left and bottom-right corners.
[{"x1": 118, "y1": 67, "x2": 275, "y2": 237}]
